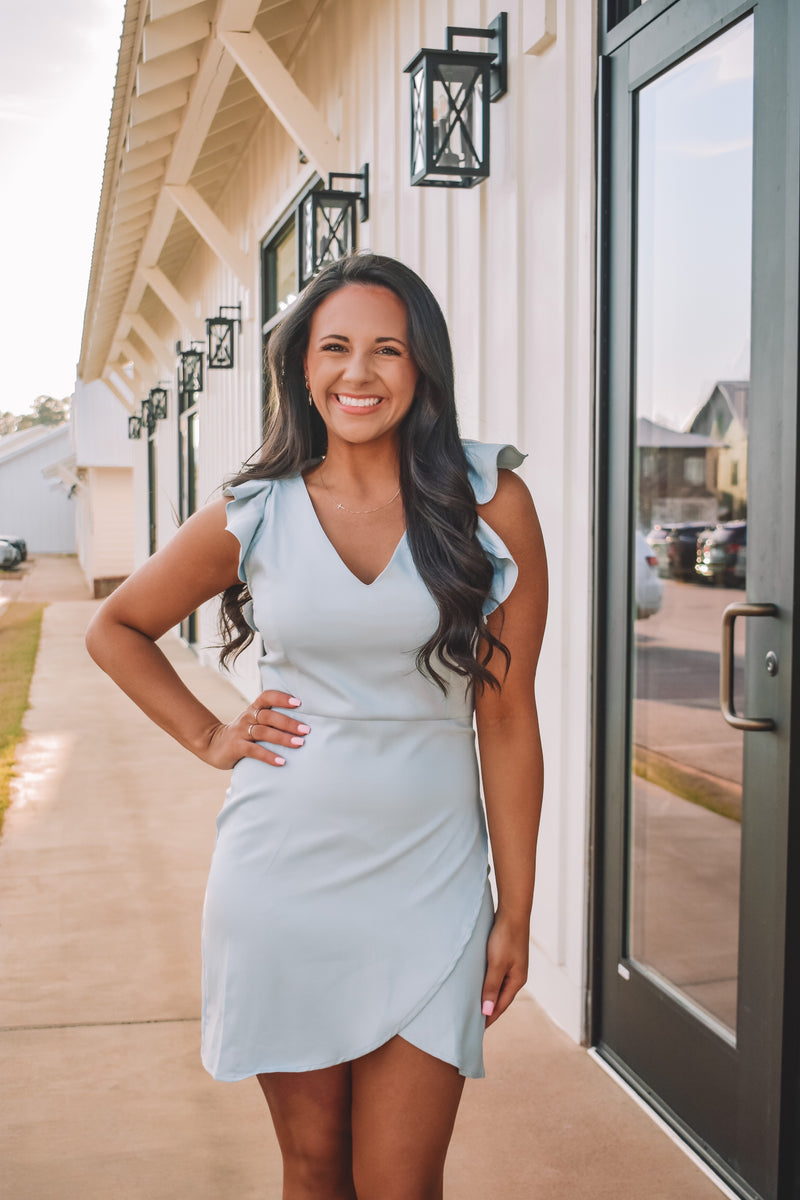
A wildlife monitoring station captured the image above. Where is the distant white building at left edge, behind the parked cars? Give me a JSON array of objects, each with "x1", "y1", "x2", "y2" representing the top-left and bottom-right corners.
[{"x1": 0, "y1": 425, "x2": 76, "y2": 554}]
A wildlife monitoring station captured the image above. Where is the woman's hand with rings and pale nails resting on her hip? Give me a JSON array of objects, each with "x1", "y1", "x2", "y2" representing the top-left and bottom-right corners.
[{"x1": 200, "y1": 691, "x2": 311, "y2": 770}]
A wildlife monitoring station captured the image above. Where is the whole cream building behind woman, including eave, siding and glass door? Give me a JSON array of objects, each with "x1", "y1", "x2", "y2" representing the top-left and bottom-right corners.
[{"x1": 79, "y1": 0, "x2": 800, "y2": 1198}]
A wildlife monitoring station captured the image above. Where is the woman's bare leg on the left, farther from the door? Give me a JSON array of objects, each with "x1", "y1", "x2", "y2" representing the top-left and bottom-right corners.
[{"x1": 258, "y1": 1063, "x2": 356, "y2": 1200}]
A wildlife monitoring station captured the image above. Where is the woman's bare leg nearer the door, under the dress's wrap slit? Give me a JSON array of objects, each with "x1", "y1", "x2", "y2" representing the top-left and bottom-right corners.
[{"x1": 351, "y1": 1037, "x2": 464, "y2": 1200}]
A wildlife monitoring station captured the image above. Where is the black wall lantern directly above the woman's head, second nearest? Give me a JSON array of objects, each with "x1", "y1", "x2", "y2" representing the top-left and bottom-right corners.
[{"x1": 297, "y1": 162, "x2": 369, "y2": 288}]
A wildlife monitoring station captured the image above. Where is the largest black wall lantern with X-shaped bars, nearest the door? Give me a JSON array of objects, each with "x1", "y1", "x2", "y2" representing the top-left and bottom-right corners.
[{"x1": 405, "y1": 12, "x2": 509, "y2": 187}]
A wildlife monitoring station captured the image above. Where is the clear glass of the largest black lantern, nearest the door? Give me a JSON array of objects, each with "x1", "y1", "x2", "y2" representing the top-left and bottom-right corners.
[{"x1": 431, "y1": 62, "x2": 488, "y2": 175}]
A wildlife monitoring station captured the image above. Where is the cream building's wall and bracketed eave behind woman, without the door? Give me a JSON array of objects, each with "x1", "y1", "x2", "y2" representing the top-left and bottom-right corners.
[{"x1": 79, "y1": 0, "x2": 594, "y2": 1039}]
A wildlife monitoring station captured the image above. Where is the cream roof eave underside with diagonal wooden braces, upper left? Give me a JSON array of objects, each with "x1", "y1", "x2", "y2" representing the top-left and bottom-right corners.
[{"x1": 78, "y1": 0, "x2": 339, "y2": 384}]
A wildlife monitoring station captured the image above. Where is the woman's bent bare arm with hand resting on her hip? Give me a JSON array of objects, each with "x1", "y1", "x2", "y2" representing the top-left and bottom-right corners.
[{"x1": 86, "y1": 500, "x2": 307, "y2": 770}]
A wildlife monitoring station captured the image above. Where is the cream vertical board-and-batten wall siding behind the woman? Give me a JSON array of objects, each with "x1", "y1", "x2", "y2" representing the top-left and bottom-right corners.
[{"x1": 142, "y1": 0, "x2": 595, "y2": 1038}]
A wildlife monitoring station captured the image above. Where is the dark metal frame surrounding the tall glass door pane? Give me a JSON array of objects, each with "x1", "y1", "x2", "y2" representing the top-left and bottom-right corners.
[{"x1": 589, "y1": 0, "x2": 800, "y2": 1200}]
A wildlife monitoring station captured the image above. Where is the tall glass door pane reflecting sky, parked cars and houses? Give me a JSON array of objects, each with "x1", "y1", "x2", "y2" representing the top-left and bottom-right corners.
[{"x1": 628, "y1": 17, "x2": 753, "y2": 1031}]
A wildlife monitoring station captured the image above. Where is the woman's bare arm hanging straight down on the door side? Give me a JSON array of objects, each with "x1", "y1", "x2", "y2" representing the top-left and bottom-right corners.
[{"x1": 475, "y1": 472, "x2": 547, "y2": 1025}]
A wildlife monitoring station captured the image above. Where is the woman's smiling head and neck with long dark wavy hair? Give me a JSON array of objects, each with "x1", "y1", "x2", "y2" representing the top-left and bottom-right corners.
[{"x1": 222, "y1": 253, "x2": 520, "y2": 685}]
